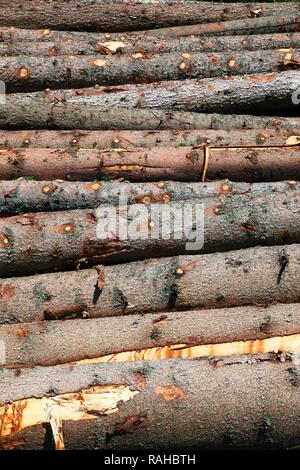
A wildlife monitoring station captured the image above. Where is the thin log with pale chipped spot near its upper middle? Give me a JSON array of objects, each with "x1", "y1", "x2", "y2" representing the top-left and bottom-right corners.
[{"x1": 0, "y1": 33, "x2": 300, "y2": 57}]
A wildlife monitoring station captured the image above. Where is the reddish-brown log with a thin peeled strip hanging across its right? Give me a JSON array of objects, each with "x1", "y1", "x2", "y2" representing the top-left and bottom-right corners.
[{"x1": 0, "y1": 145, "x2": 300, "y2": 182}]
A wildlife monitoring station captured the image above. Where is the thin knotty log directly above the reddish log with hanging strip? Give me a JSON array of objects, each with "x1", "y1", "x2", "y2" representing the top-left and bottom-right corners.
[{"x1": 0, "y1": 129, "x2": 300, "y2": 149}]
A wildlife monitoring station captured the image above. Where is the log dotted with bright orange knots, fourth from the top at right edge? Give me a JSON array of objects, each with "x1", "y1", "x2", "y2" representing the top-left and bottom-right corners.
[{"x1": 0, "y1": 50, "x2": 300, "y2": 92}]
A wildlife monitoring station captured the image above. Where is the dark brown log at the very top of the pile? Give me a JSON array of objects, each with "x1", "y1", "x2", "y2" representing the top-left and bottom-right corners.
[{"x1": 0, "y1": 0, "x2": 299, "y2": 31}]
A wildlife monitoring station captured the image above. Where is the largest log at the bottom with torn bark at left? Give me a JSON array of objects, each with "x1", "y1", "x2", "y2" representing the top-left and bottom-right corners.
[{"x1": 1, "y1": 355, "x2": 300, "y2": 450}]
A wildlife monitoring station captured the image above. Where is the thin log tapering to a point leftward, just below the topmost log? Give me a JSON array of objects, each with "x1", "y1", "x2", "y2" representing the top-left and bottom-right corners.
[{"x1": 127, "y1": 13, "x2": 300, "y2": 38}]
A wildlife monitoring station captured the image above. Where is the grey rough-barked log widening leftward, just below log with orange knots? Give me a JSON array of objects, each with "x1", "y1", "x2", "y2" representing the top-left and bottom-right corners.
[{"x1": 8, "y1": 71, "x2": 300, "y2": 115}]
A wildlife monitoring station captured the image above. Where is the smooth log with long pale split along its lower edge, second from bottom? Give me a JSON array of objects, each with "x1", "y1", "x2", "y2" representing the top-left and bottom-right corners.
[{"x1": 0, "y1": 304, "x2": 300, "y2": 368}]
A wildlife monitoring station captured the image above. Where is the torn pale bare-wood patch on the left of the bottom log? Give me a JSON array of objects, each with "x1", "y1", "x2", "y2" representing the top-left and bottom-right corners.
[{"x1": 0, "y1": 385, "x2": 140, "y2": 450}]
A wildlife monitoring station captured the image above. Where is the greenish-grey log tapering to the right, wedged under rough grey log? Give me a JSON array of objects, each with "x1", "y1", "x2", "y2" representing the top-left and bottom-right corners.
[{"x1": 0, "y1": 93, "x2": 300, "y2": 130}]
